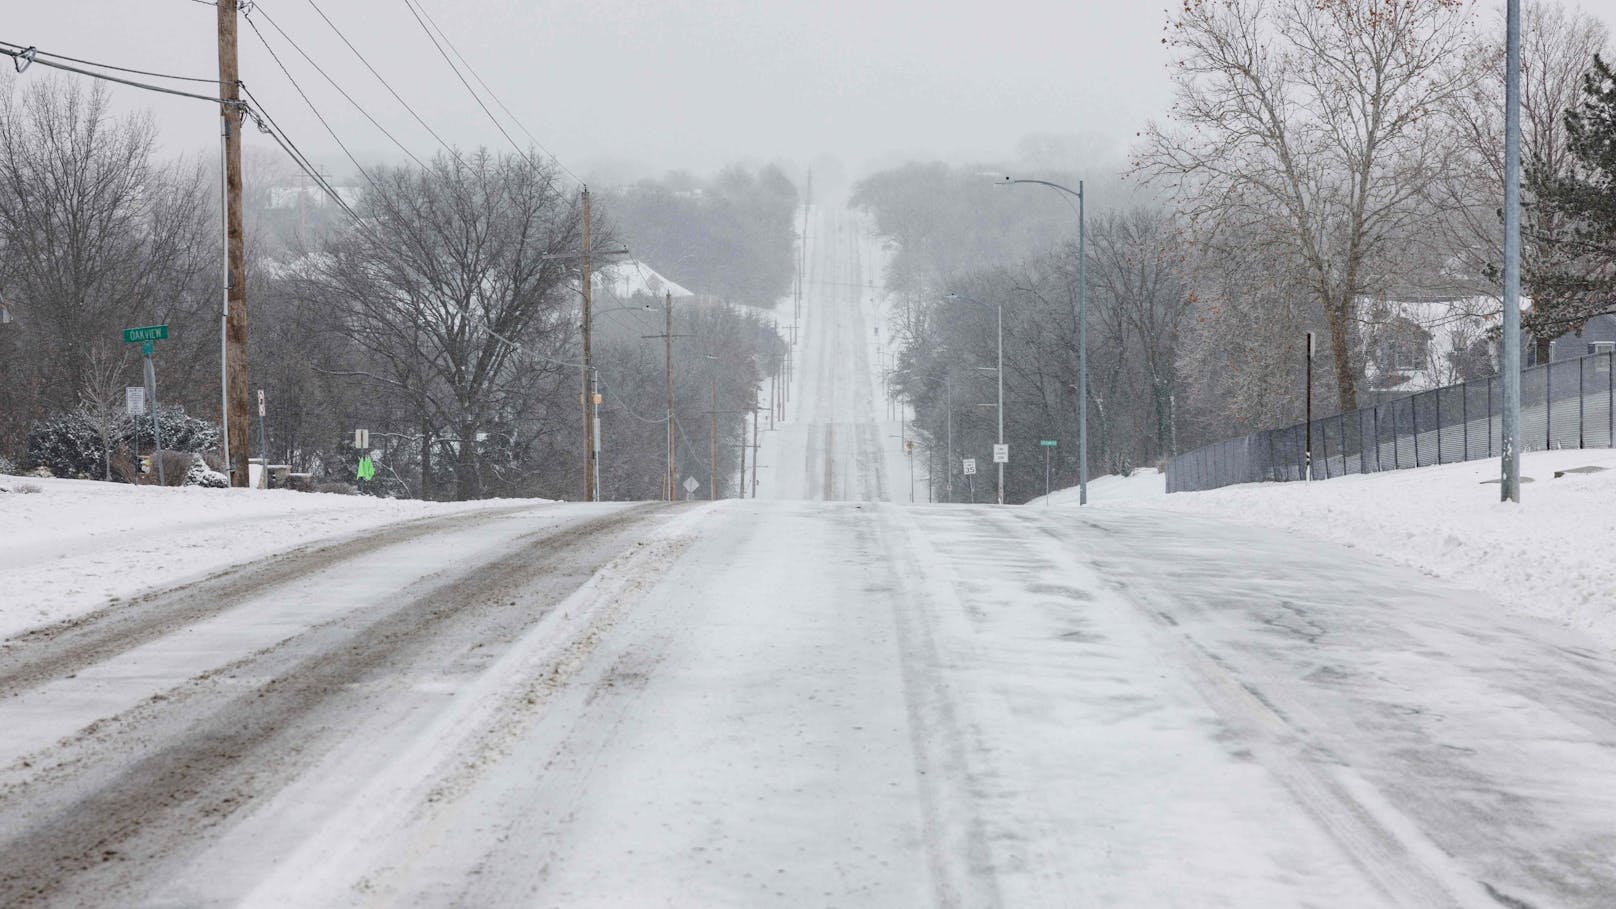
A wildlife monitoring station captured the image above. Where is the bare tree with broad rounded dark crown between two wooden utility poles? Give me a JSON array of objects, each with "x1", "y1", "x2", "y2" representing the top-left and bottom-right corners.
[{"x1": 299, "y1": 150, "x2": 588, "y2": 498}]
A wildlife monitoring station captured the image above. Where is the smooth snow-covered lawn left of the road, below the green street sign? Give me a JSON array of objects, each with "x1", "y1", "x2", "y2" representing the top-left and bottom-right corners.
[{"x1": 0, "y1": 476, "x2": 546, "y2": 639}]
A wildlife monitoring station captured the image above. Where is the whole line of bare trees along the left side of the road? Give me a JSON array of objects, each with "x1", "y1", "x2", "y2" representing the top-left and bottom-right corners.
[{"x1": 0, "y1": 69, "x2": 797, "y2": 498}]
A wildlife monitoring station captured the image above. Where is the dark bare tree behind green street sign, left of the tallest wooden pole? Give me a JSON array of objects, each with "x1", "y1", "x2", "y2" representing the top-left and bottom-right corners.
[{"x1": 0, "y1": 78, "x2": 218, "y2": 449}]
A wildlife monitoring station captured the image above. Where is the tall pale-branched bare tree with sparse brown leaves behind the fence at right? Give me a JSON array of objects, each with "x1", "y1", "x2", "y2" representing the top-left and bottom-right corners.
[{"x1": 1138, "y1": 0, "x2": 1474, "y2": 409}]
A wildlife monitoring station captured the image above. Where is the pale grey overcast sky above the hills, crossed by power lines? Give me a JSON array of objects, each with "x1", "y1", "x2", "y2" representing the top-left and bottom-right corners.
[{"x1": 0, "y1": 0, "x2": 1616, "y2": 189}]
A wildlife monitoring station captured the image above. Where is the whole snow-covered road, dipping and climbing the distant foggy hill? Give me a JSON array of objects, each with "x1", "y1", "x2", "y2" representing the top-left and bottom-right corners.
[{"x1": 0, "y1": 212, "x2": 1616, "y2": 907}]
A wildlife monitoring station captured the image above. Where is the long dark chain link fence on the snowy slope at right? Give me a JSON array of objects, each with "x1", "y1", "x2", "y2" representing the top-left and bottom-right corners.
[{"x1": 1167, "y1": 353, "x2": 1616, "y2": 492}]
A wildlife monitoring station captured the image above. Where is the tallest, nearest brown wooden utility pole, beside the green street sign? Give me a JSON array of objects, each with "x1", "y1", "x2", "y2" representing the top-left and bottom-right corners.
[{"x1": 218, "y1": 0, "x2": 250, "y2": 487}]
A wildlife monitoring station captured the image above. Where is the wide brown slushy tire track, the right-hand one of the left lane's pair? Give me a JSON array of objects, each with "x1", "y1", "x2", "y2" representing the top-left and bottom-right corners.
[{"x1": 0, "y1": 505, "x2": 659, "y2": 906}]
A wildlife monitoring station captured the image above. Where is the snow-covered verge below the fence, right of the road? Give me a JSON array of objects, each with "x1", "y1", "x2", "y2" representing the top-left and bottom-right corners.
[{"x1": 1034, "y1": 450, "x2": 1616, "y2": 649}]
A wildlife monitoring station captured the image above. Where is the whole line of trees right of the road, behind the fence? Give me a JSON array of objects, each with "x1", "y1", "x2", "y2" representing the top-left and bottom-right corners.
[{"x1": 853, "y1": 0, "x2": 1616, "y2": 500}]
